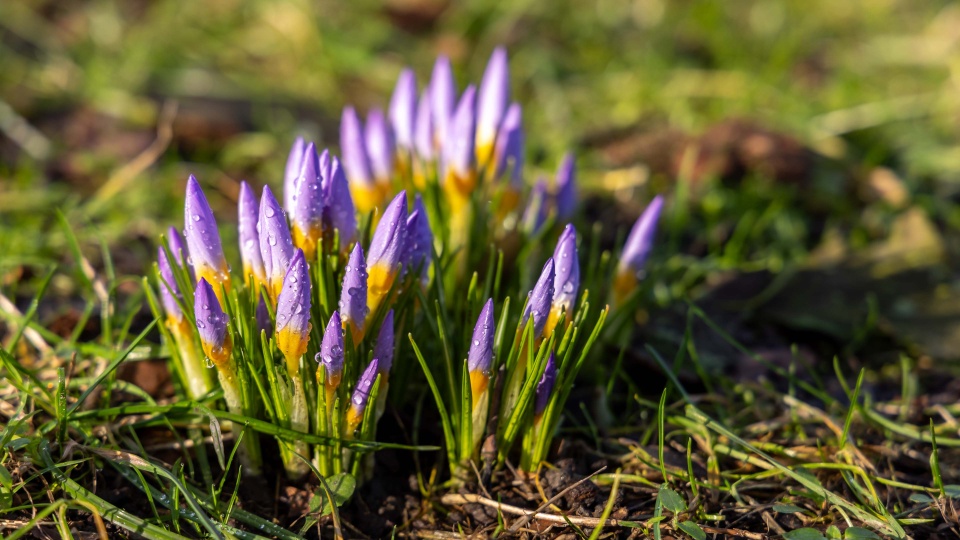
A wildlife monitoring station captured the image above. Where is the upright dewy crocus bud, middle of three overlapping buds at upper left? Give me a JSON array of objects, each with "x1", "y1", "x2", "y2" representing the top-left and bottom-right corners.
[{"x1": 292, "y1": 143, "x2": 326, "y2": 261}]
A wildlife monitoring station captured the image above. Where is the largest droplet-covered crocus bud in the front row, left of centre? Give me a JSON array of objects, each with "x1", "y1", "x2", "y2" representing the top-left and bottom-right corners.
[{"x1": 277, "y1": 249, "x2": 310, "y2": 376}]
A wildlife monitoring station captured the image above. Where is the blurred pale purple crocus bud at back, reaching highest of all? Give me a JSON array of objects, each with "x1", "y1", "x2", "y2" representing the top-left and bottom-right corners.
[{"x1": 477, "y1": 47, "x2": 510, "y2": 167}]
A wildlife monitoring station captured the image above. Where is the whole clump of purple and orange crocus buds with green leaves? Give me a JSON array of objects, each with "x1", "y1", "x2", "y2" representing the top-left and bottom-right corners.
[{"x1": 154, "y1": 48, "x2": 663, "y2": 488}]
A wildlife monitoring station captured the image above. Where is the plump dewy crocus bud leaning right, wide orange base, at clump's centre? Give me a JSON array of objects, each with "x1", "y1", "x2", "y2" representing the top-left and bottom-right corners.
[{"x1": 367, "y1": 191, "x2": 407, "y2": 314}]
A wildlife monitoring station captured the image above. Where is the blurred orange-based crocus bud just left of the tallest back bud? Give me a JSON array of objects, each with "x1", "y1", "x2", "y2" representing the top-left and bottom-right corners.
[{"x1": 443, "y1": 85, "x2": 477, "y2": 201}]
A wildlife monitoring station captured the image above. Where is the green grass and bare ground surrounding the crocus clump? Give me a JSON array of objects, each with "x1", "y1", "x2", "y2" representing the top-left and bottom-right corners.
[{"x1": 0, "y1": 0, "x2": 960, "y2": 539}]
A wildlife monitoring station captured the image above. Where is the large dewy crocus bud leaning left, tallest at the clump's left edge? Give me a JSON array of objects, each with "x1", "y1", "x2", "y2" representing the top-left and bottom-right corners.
[{"x1": 183, "y1": 174, "x2": 230, "y2": 302}]
